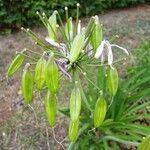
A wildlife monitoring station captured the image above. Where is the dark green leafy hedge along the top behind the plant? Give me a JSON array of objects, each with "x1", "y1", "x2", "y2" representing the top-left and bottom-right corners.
[{"x1": 0, "y1": 0, "x2": 149, "y2": 30}]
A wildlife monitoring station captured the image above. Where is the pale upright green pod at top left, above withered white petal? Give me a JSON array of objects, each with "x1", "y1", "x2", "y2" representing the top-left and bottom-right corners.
[{"x1": 47, "y1": 11, "x2": 57, "y2": 41}]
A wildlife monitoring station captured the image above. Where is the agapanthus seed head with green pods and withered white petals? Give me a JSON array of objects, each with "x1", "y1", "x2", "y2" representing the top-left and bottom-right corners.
[{"x1": 7, "y1": 4, "x2": 149, "y2": 149}]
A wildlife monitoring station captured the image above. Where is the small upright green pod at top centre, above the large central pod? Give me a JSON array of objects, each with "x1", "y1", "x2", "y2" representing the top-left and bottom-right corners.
[{"x1": 65, "y1": 18, "x2": 73, "y2": 41}]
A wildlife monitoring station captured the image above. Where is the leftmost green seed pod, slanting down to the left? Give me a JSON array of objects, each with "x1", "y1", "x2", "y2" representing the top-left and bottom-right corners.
[{"x1": 7, "y1": 51, "x2": 24, "y2": 77}]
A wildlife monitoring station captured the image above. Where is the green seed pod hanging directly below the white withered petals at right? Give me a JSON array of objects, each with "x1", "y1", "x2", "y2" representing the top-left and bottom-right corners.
[{"x1": 107, "y1": 68, "x2": 119, "y2": 96}]
